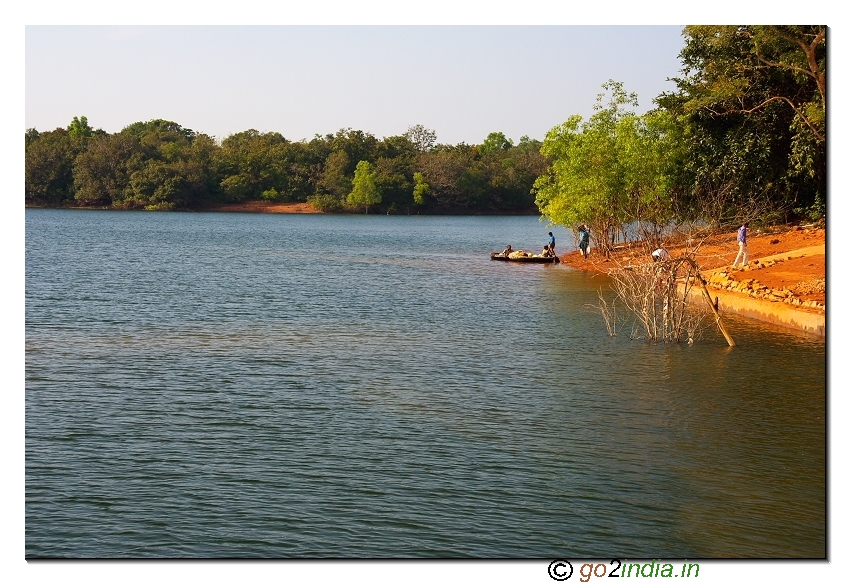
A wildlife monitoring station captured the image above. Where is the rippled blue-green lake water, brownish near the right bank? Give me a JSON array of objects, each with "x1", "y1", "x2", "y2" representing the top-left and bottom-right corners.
[{"x1": 26, "y1": 209, "x2": 826, "y2": 559}]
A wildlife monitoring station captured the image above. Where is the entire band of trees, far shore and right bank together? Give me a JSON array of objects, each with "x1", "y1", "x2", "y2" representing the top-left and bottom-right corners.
[{"x1": 25, "y1": 26, "x2": 826, "y2": 230}]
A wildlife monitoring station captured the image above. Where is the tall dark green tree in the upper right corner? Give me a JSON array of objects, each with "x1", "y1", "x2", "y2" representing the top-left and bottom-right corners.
[{"x1": 656, "y1": 26, "x2": 826, "y2": 218}]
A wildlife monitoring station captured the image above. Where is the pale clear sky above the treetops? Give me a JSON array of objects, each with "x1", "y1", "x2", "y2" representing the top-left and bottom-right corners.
[{"x1": 25, "y1": 26, "x2": 683, "y2": 144}]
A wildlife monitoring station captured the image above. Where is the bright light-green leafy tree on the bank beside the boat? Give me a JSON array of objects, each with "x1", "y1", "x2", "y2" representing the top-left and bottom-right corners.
[{"x1": 534, "y1": 81, "x2": 676, "y2": 252}]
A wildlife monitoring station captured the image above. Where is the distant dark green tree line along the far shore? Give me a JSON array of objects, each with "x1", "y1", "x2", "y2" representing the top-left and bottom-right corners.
[{"x1": 25, "y1": 117, "x2": 546, "y2": 214}]
